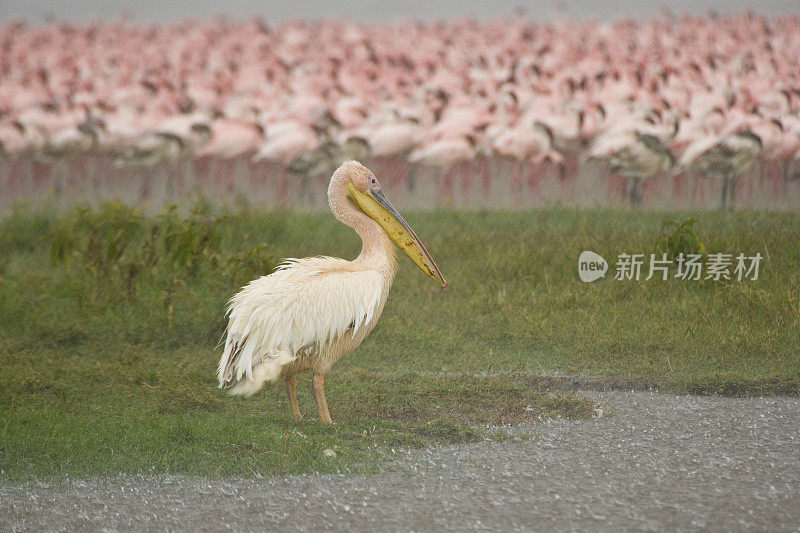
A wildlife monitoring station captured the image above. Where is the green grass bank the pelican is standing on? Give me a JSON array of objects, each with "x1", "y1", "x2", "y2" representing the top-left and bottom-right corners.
[{"x1": 0, "y1": 204, "x2": 800, "y2": 479}]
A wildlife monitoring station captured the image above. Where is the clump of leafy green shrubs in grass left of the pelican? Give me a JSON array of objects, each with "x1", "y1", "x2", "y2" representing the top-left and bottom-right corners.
[{"x1": 48, "y1": 202, "x2": 276, "y2": 302}]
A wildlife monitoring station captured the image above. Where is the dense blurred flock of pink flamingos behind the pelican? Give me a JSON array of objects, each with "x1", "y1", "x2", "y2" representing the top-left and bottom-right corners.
[{"x1": 0, "y1": 11, "x2": 800, "y2": 208}]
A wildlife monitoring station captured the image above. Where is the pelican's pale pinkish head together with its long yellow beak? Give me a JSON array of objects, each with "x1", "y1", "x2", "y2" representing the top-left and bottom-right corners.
[{"x1": 329, "y1": 161, "x2": 447, "y2": 288}]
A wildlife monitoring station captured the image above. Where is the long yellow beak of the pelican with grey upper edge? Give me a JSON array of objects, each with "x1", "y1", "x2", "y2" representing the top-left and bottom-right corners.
[{"x1": 347, "y1": 183, "x2": 447, "y2": 289}]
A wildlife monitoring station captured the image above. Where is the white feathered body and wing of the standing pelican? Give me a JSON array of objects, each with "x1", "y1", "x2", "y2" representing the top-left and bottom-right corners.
[{"x1": 218, "y1": 257, "x2": 384, "y2": 395}]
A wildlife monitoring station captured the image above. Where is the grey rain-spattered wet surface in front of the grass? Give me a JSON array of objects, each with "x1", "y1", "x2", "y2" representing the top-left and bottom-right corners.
[{"x1": 0, "y1": 391, "x2": 800, "y2": 531}]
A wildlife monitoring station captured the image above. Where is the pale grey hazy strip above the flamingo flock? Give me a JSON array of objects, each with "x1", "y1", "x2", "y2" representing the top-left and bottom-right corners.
[{"x1": 0, "y1": 0, "x2": 800, "y2": 22}]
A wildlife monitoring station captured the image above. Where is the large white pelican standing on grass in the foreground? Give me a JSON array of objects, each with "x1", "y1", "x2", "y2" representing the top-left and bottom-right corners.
[{"x1": 217, "y1": 161, "x2": 447, "y2": 423}]
